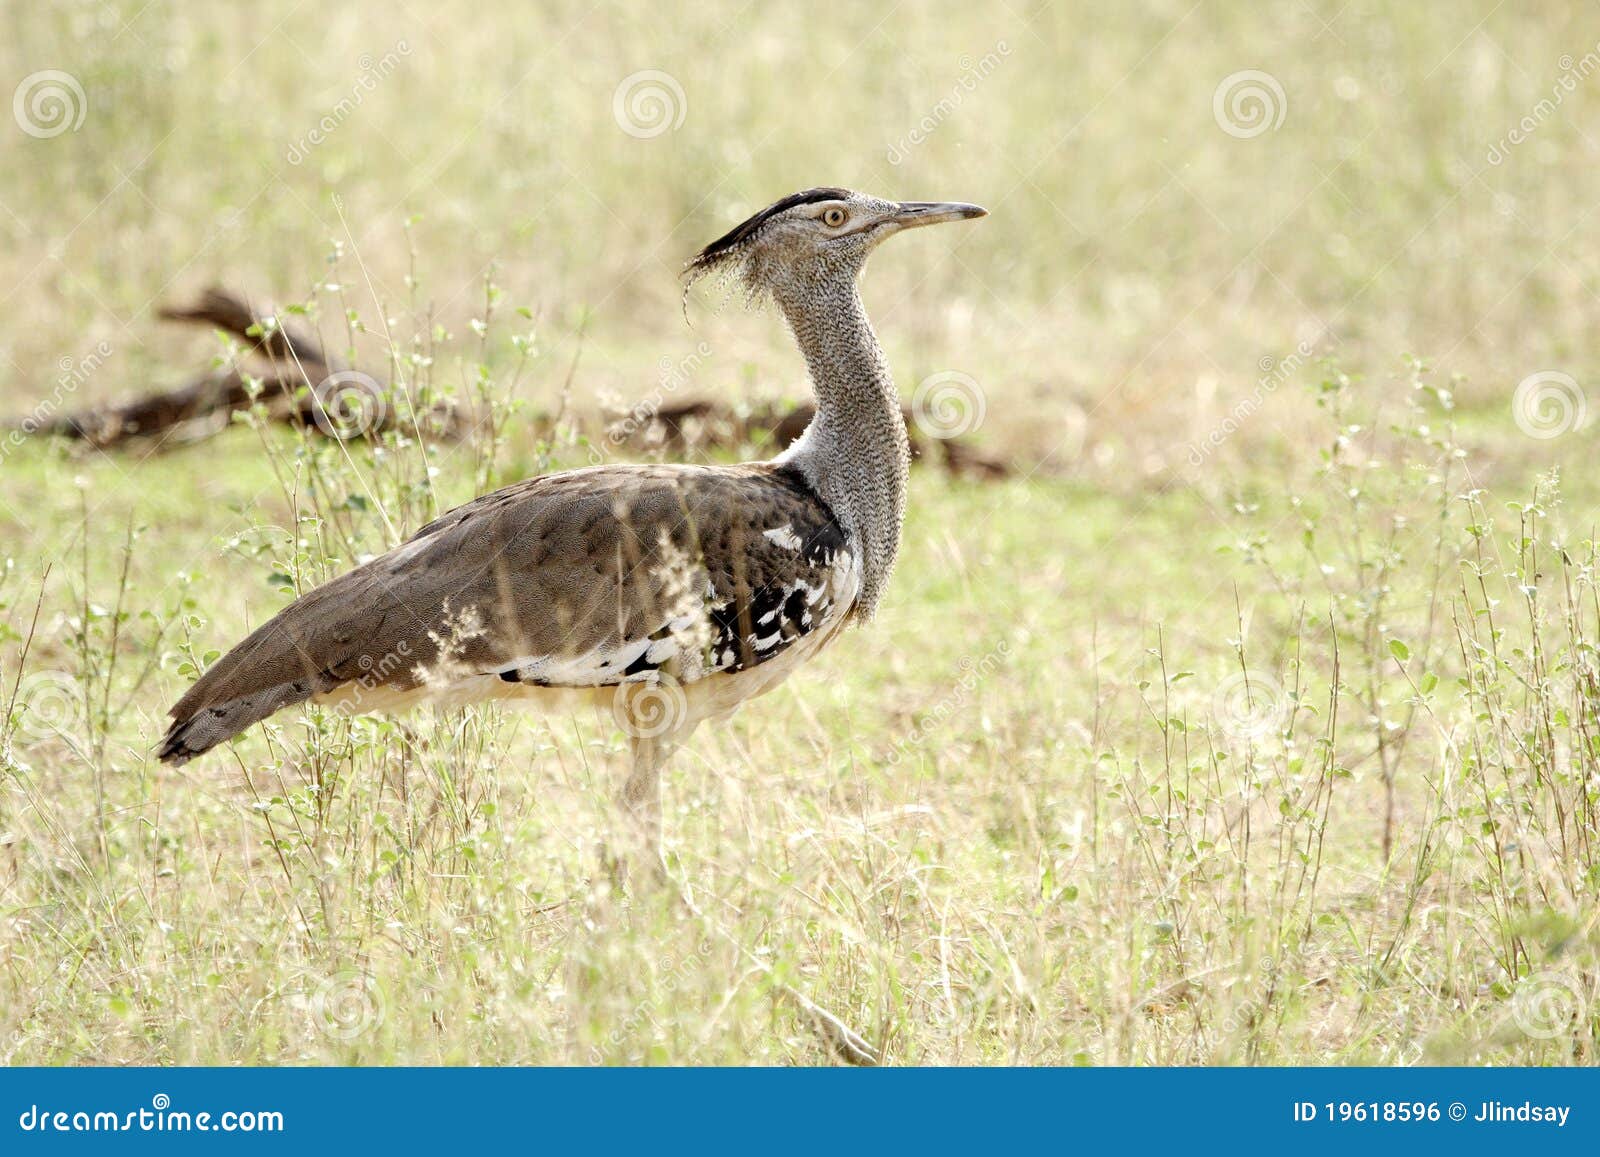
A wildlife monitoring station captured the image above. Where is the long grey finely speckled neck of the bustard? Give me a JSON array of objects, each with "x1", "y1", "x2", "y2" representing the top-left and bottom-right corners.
[{"x1": 774, "y1": 275, "x2": 910, "y2": 618}]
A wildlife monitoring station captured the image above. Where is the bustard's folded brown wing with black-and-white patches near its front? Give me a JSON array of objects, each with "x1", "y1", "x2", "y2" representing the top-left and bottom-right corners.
[{"x1": 158, "y1": 462, "x2": 854, "y2": 762}]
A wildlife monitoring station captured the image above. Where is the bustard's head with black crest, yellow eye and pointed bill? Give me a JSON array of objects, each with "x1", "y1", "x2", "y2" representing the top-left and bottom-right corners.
[{"x1": 683, "y1": 189, "x2": 987, "y2": 301}]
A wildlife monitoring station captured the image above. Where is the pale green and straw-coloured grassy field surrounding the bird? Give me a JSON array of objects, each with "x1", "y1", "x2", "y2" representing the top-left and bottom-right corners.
[{"x1": 0, "y1": 0, "x2": 1600, "y2": 1064}]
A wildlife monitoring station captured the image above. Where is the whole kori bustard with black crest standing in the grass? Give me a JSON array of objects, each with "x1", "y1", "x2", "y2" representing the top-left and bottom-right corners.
[{"x1": 158, "y1": 189, "x2": 984, "y2": 871}]
